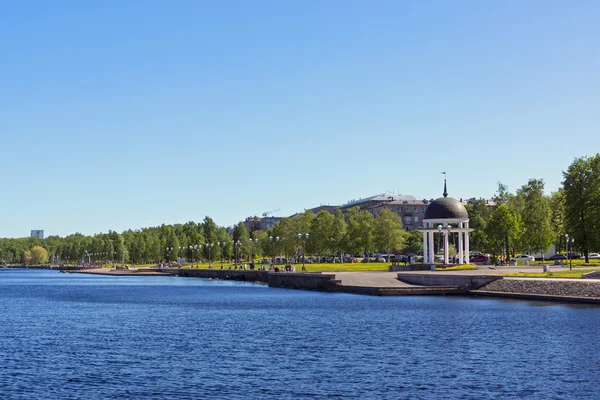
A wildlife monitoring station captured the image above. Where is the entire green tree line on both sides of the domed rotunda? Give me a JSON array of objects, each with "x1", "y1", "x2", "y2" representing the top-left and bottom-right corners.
[{"x1": 0, "y1": 154, "x2": 600, "y2": 264}]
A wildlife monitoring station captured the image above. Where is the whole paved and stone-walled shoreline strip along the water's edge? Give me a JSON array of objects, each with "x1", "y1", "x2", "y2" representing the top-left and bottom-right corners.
[{"x1": 52, "y1": 268, "x2": 600, "y2": 305}]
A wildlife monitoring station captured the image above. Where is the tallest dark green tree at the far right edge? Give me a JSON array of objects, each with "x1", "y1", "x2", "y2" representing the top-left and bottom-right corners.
[{"x1": 563, "y1": 154, "x2": 600, "y2": 263}]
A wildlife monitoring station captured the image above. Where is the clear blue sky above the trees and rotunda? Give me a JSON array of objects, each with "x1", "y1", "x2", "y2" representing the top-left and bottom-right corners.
[{"x1": 0, "y1": 0, "x2": 600, "y2": 237}]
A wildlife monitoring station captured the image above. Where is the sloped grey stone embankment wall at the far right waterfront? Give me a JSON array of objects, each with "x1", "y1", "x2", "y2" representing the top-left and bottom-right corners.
[{"x1": 480, "y1": 279, "x2": 600, "y2": 299}]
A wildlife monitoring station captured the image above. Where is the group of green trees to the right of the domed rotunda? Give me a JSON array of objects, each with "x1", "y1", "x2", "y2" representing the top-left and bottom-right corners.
[{"x1": 467, "y1": 154, "x2": 600, "y2": 262}]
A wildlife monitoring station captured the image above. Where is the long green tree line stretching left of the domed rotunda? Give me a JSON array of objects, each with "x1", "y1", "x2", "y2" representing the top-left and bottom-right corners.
[{"x1": 0, "y1": 207, "x2": 420, "y2": 264}]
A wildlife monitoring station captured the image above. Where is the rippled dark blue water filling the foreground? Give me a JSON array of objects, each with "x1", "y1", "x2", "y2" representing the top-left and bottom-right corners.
[{"x1": 0, "y1": 270, "x2": 600, "y2": 399}]
